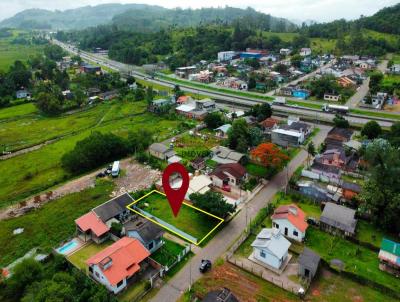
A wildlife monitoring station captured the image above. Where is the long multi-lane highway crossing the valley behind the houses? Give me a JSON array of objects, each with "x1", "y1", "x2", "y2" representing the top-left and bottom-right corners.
[{"x1": 52, "y1": 39, "x2": 393, "y2": 127}]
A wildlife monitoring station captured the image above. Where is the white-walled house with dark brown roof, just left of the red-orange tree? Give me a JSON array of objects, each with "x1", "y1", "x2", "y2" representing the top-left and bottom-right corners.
[{"x1": 210, "y1": 163, "x2": 247, "y2": 188}]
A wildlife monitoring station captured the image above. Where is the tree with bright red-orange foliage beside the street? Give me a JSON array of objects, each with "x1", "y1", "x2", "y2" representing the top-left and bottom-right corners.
[{"x1": 250, "y1": 143, "x2": 289, "y2": 168}]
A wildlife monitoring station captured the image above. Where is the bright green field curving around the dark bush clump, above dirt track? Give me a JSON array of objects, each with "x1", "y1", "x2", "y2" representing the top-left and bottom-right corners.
[{"x1": 0, "y1": 103, "x2": 180, "y2": 207}]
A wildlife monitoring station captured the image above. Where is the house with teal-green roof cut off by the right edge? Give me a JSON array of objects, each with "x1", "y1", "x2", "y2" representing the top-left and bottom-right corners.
[{"x1": 378, "y1": 238, "x2": 400, "y2": 276}]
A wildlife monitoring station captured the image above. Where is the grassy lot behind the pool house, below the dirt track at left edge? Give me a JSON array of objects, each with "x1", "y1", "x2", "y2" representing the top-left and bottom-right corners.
[{"x1": 0, "y1": 181, "x2": 113, "y2": 267}]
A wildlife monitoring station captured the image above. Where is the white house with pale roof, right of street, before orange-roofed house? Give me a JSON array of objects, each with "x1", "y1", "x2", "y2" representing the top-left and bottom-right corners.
[{"x1": 250, "y1": 229, "x2": 291, "y2": 269}]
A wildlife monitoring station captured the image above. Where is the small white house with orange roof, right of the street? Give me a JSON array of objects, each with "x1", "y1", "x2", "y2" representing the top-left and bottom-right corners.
[{"x1": 271, "y1": 204, "x2": 308, "y2": 242}]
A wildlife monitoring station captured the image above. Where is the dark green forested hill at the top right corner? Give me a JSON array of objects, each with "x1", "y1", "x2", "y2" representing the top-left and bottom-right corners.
[{"x1": 301, "y1": 3, "x2": 400, "y2": 39}]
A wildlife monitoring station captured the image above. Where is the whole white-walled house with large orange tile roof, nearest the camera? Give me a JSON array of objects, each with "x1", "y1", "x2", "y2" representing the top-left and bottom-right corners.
[{"x1": 86, "y1": 237, "x2": 150, "y2": 294}]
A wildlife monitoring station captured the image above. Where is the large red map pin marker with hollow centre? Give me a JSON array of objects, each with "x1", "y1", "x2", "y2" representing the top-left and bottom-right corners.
[{"x1": 162, "y1": 163, "x2": 189, "y2": 217}]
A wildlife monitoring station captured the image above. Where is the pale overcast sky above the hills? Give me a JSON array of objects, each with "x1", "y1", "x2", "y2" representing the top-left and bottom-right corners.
[{"x1": 0, "y1": 0, "x2": 399, "y2": 21}]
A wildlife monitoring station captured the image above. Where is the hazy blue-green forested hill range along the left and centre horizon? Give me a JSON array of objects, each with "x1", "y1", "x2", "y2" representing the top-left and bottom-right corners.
[{"x1": 0, "y1": 4, "x2": 296, "y2": 32}]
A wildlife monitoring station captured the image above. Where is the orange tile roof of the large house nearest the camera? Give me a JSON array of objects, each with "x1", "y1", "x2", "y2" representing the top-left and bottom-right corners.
[{"x1": 86, "y1": 237, "x2": 150, "y2": 286}]
